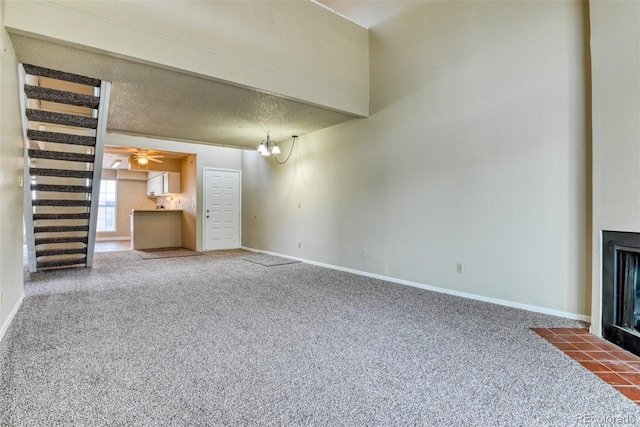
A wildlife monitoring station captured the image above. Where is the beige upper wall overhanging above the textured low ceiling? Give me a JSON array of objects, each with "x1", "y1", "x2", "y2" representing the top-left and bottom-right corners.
[{"x1": 6, "y1": 0, "x2": 369, "y2": 116}]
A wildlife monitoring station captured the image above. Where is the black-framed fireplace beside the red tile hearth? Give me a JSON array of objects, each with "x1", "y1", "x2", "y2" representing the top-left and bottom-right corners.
[{"x1": 602, "y1": 231, "x2": 640, "y2": 355}]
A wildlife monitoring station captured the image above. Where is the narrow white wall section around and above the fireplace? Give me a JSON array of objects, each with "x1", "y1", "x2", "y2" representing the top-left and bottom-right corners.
[{"x1": 590, "y1": 1, "x2": 640, "y2": 334}]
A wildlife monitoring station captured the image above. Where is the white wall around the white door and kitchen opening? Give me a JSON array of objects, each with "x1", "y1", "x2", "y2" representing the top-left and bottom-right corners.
[{"x1": 105, "y1": 133, "x2": 242, "y2": 251}]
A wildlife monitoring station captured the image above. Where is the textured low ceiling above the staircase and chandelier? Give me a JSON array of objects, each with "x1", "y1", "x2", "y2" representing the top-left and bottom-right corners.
[{"x1": 11, "y1": 34, "x2": 355, "y2": 152}]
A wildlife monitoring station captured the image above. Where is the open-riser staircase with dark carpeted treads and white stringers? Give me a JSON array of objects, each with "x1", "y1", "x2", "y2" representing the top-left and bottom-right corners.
[{"x1": 20, "y1": 64, "x2": 110, "y2": 273}]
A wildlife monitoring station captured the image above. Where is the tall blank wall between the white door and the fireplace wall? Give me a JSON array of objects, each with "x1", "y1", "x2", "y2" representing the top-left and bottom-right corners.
[{"x1": 242, "y1": 1, "x2": 590, "y2": 318}]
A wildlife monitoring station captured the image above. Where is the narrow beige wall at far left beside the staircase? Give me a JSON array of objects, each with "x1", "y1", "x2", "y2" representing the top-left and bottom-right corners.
[{"x1": 0, "y1": 0, "x2": 23, "y2": 339}]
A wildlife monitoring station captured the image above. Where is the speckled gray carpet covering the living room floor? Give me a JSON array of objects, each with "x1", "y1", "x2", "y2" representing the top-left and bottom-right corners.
[{"x1": 0, "y1": 251, "x2": 640, "y2": 426}]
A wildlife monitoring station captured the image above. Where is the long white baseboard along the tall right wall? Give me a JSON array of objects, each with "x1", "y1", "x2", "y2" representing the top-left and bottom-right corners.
[{"x1": 242, "y1": 246, "x2": 591, "y2": 323}]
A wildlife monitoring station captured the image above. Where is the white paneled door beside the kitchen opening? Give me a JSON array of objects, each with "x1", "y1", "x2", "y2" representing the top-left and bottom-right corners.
[{"x1": 203, "y1": 168, "x2": 240, "y2": 251}]
